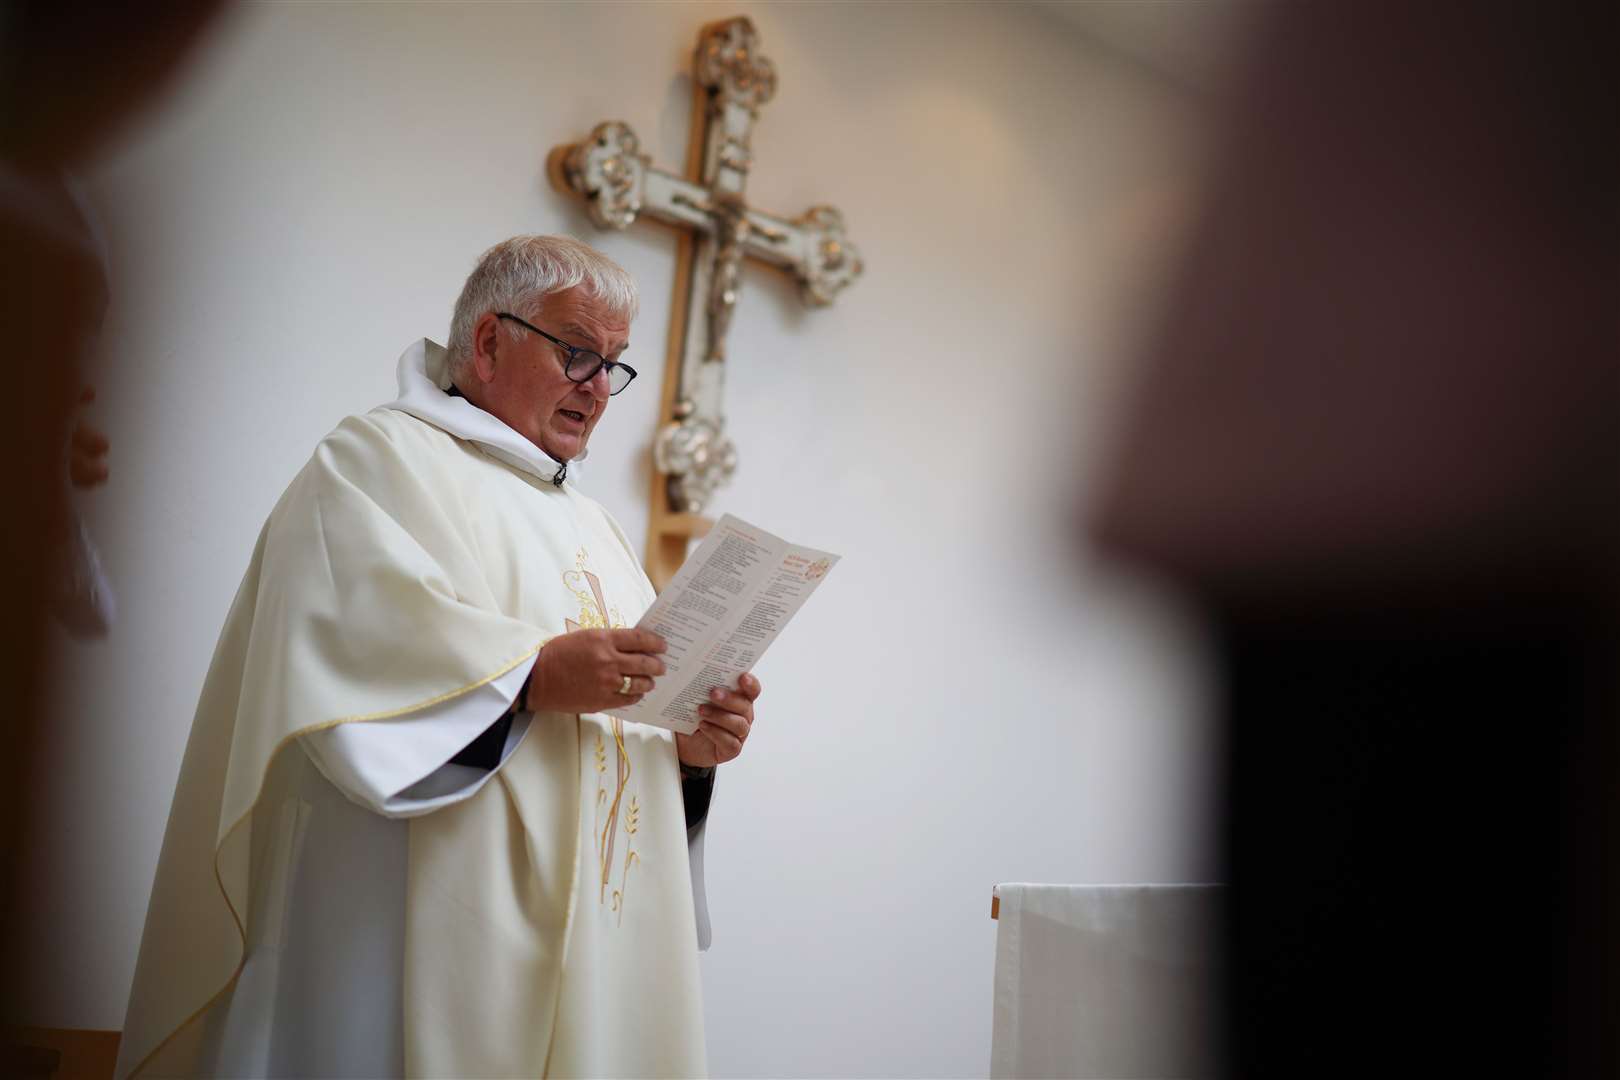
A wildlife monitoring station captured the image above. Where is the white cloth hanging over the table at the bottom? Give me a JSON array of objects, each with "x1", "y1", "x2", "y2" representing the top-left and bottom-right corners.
[{"x1": 990, "y1": 884, "x2": 1220, "y2": 1080}]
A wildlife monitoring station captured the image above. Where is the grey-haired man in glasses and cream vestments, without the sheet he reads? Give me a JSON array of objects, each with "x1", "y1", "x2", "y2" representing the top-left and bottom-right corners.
[{"x1": 118, "y1": 236, "x2": 760, "y2": 1077}]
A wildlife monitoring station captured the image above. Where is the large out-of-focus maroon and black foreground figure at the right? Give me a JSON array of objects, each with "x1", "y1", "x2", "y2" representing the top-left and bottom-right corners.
[{"x1": 1094, "y1": 0, "x2": 1620, "y2": 1078}]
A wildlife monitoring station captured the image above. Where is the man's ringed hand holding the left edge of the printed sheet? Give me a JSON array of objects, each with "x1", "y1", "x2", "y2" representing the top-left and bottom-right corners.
[{"x1": 527, "y1": 630, "x2": 664, "y2": 712}]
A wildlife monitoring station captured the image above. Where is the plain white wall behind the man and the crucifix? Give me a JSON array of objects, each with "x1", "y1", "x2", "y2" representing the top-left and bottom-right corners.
[{"x1": 31, "y1": 3, "x2": 1212, "y2": 1075}]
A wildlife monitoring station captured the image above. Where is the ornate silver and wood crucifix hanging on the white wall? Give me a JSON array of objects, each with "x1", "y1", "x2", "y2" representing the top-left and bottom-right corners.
[{"x1": 546, "y1": 18, "x2": 862, "y2": 589}]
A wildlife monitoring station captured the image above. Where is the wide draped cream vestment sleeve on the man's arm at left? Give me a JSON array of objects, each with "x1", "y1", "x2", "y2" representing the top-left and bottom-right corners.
[{"x1": 253, "y1": 418, "x2": 546, "y2": 818}]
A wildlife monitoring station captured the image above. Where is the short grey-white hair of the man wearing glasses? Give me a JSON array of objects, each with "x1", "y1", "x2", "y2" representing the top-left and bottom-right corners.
[{"x1": 447, "y1": 236, "x2": 640, "y2": 377}]
